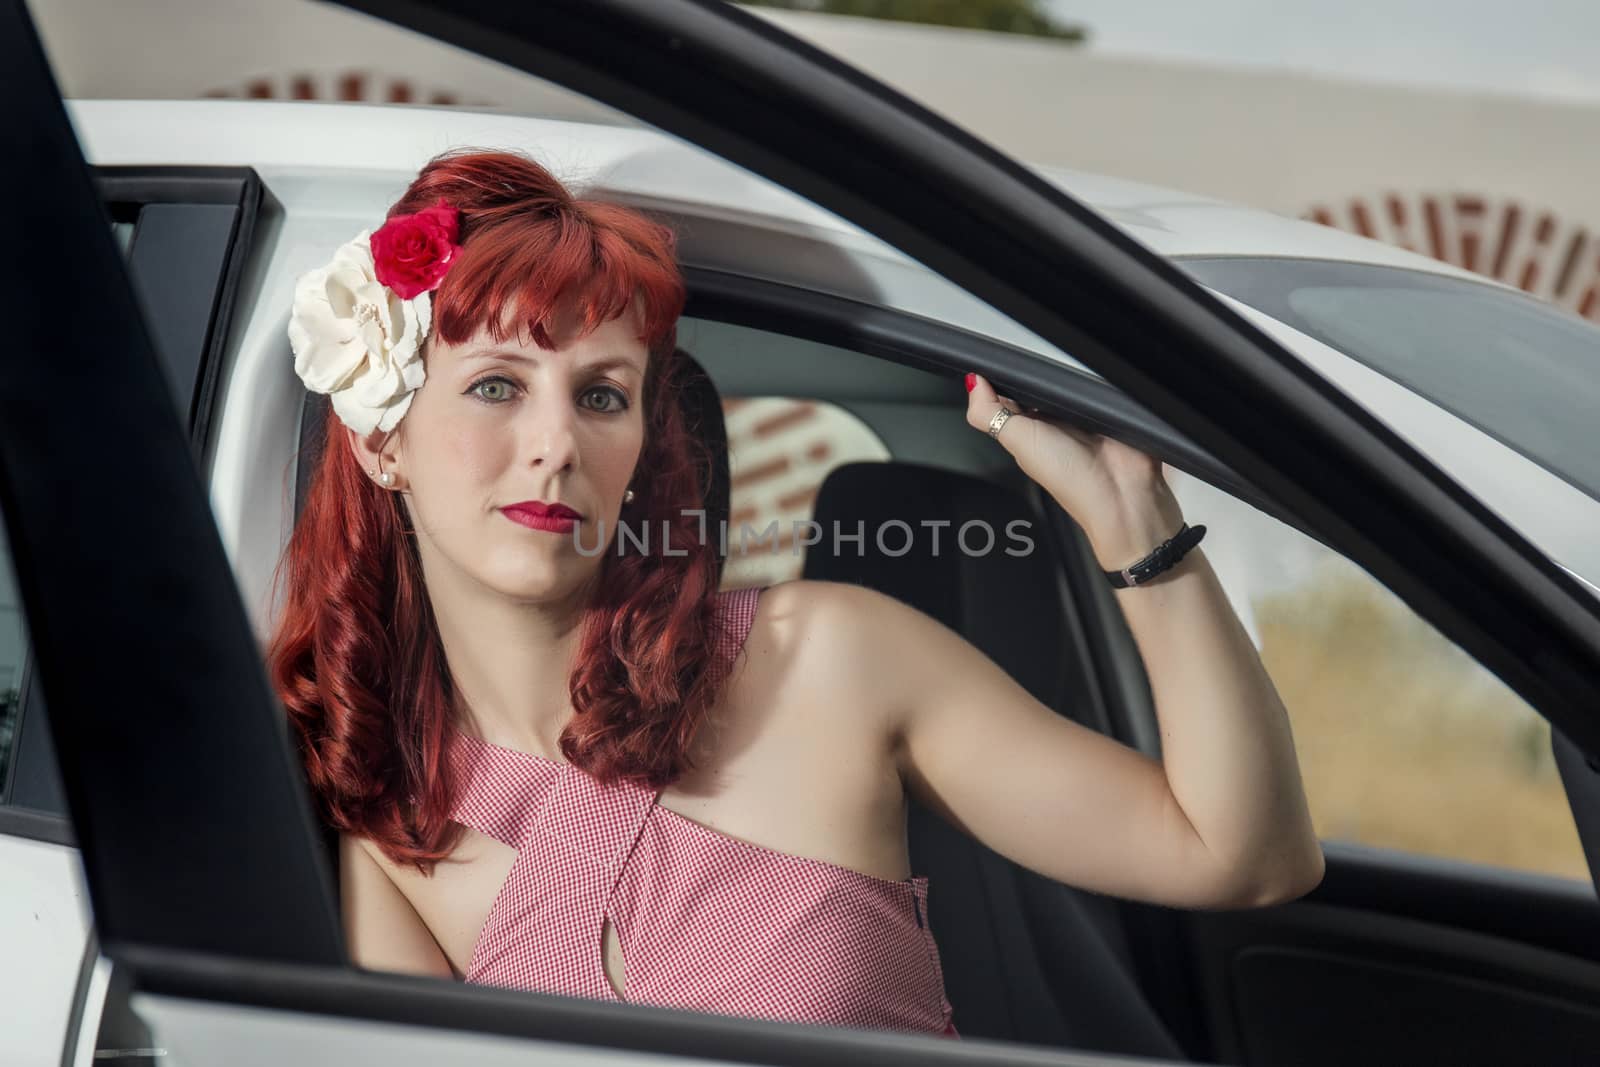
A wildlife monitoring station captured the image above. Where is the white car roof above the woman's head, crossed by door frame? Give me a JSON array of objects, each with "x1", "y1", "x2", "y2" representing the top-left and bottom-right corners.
[{"x1": 69, "y1": 101, "x2": 1491, "y2": 337}]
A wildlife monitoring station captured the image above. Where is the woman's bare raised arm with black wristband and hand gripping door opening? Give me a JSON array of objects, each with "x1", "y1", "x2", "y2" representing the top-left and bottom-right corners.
[{"x1": 790, "y1": 378, "x2": 1323, "y2": 907}]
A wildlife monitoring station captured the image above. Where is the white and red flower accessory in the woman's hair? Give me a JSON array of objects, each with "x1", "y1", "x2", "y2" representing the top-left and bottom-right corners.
[{"x1": 290, "y1": 200, "x2": 461, "y2": 435}]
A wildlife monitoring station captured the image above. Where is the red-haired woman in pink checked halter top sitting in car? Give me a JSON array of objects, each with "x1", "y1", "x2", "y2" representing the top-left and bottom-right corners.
[{"x1": 270, "y1": 152, "x2": 1322, "y2": 1037}]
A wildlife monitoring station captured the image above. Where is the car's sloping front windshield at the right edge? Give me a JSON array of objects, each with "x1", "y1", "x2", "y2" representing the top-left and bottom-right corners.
[{"x1": 1178, "y1": 259, "x2": 1600, "y2": 508}]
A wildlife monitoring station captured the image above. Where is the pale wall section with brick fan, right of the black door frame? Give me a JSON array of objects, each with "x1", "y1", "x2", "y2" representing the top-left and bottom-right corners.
[{"x1": 755, "y1": 13, "x2": 1600, "y2": 320}]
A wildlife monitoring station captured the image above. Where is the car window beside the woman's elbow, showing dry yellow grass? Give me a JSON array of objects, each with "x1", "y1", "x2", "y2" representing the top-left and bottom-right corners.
[{"x1": 1168, "y1": 470, "x2": 1587, "y2": 880}]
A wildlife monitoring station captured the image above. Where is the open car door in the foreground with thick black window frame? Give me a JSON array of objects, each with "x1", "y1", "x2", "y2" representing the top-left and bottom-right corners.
[{"x1": 9, "y1": 0, "x2": 1600, "y2": 1062}]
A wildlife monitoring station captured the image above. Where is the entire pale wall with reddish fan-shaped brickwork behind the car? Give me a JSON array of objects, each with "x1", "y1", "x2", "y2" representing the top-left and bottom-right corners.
[{"x1": 30, "y1": 0, "x2": 1600, "y2": 318}]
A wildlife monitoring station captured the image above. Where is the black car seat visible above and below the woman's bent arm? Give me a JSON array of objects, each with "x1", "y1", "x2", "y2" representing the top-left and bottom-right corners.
[{"x1": 803, "y1": 462, "x2": 1184, "y2": 1059}]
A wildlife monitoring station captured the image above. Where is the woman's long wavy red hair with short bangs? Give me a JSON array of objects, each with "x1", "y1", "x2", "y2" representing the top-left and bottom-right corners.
[{"x1": 267, "y1": 152, "x2": 720, "y2": 873}]
